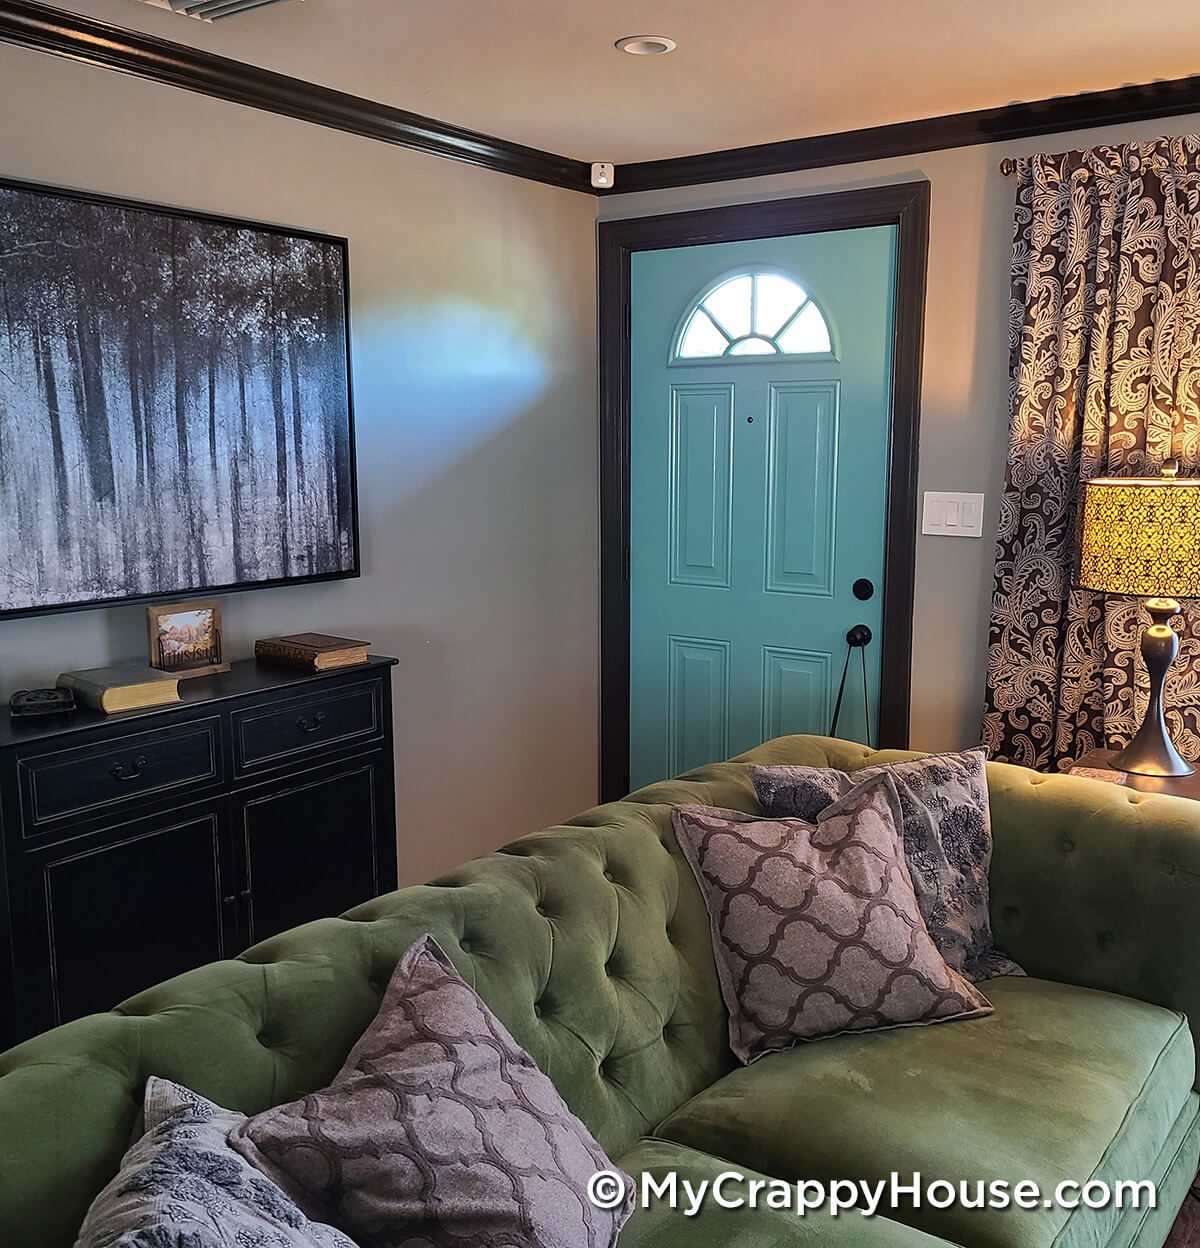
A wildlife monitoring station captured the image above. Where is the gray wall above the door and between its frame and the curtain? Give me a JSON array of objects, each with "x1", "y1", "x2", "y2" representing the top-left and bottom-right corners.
[{"x1": 600, "y1": 109, "x2": 1200, "y2": 750}]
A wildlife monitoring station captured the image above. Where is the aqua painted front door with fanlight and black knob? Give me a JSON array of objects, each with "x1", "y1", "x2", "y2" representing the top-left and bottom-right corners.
[{"x1": 630, "y1": 226, "x2": 897, "y2": 787}]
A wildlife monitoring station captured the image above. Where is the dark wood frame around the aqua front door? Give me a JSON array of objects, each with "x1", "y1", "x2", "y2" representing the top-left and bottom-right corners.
[{"x1": 598, "y1": 181, "x2": 929, "y2": 801}]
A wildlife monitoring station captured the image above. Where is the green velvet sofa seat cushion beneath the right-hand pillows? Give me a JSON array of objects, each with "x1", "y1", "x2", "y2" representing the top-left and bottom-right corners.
[{"x1": 656, "y1": 977, "x2": 1195, "y2": 1248}]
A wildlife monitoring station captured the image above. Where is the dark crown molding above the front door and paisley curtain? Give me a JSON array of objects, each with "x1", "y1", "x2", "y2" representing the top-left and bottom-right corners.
[{"x1": 606, "y1": 76, "x2": 1200, "y2": 193}]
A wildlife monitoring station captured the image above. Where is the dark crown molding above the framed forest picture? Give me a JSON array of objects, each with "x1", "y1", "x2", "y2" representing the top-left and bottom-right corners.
[{"x1": 0, "y1": 0, "x2": 591, "y2": 193}]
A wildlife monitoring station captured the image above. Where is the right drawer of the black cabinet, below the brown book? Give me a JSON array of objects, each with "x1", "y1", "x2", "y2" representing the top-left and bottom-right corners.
[{"x1": 233, "y1": 680, "x2": 383, "y2": 775}]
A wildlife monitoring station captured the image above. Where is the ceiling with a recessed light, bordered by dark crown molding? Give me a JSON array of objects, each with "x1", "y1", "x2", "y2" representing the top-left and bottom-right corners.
[{"x1": 59, "y1": 0, "x2": 1200, "y2": 165}]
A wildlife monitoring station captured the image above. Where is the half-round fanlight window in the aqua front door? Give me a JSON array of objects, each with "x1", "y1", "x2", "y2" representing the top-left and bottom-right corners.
[{"x1": 675, "y1": 272, "x2": 833, "y2": 359}]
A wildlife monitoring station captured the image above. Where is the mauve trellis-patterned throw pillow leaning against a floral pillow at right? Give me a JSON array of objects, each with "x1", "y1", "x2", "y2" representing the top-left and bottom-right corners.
[{"x1": 672, "y1": 775, "x2": 992, "y2": 1062}]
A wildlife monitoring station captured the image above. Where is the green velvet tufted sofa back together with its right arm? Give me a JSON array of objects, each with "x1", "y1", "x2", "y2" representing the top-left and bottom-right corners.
[{"x1": 0, "y1": 736, "x2": 1200, "y2": 1248}]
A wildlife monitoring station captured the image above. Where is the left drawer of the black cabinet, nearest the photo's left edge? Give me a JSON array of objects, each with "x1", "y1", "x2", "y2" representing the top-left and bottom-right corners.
[{"x1": 17, "y1": 718, "x2": 221, "y2": 836}]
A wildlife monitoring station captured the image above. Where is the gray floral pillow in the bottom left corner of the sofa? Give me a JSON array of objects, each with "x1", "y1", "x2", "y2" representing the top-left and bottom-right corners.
[{"x1": 75, "y1": 1076, "x2": 354, "y2": 1248}]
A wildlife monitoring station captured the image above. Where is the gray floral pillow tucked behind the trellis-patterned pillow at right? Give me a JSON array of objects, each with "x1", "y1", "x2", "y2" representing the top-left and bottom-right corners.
[{"x1": 750, "y1": 750, "x2": 1024, "y2": 983}]
